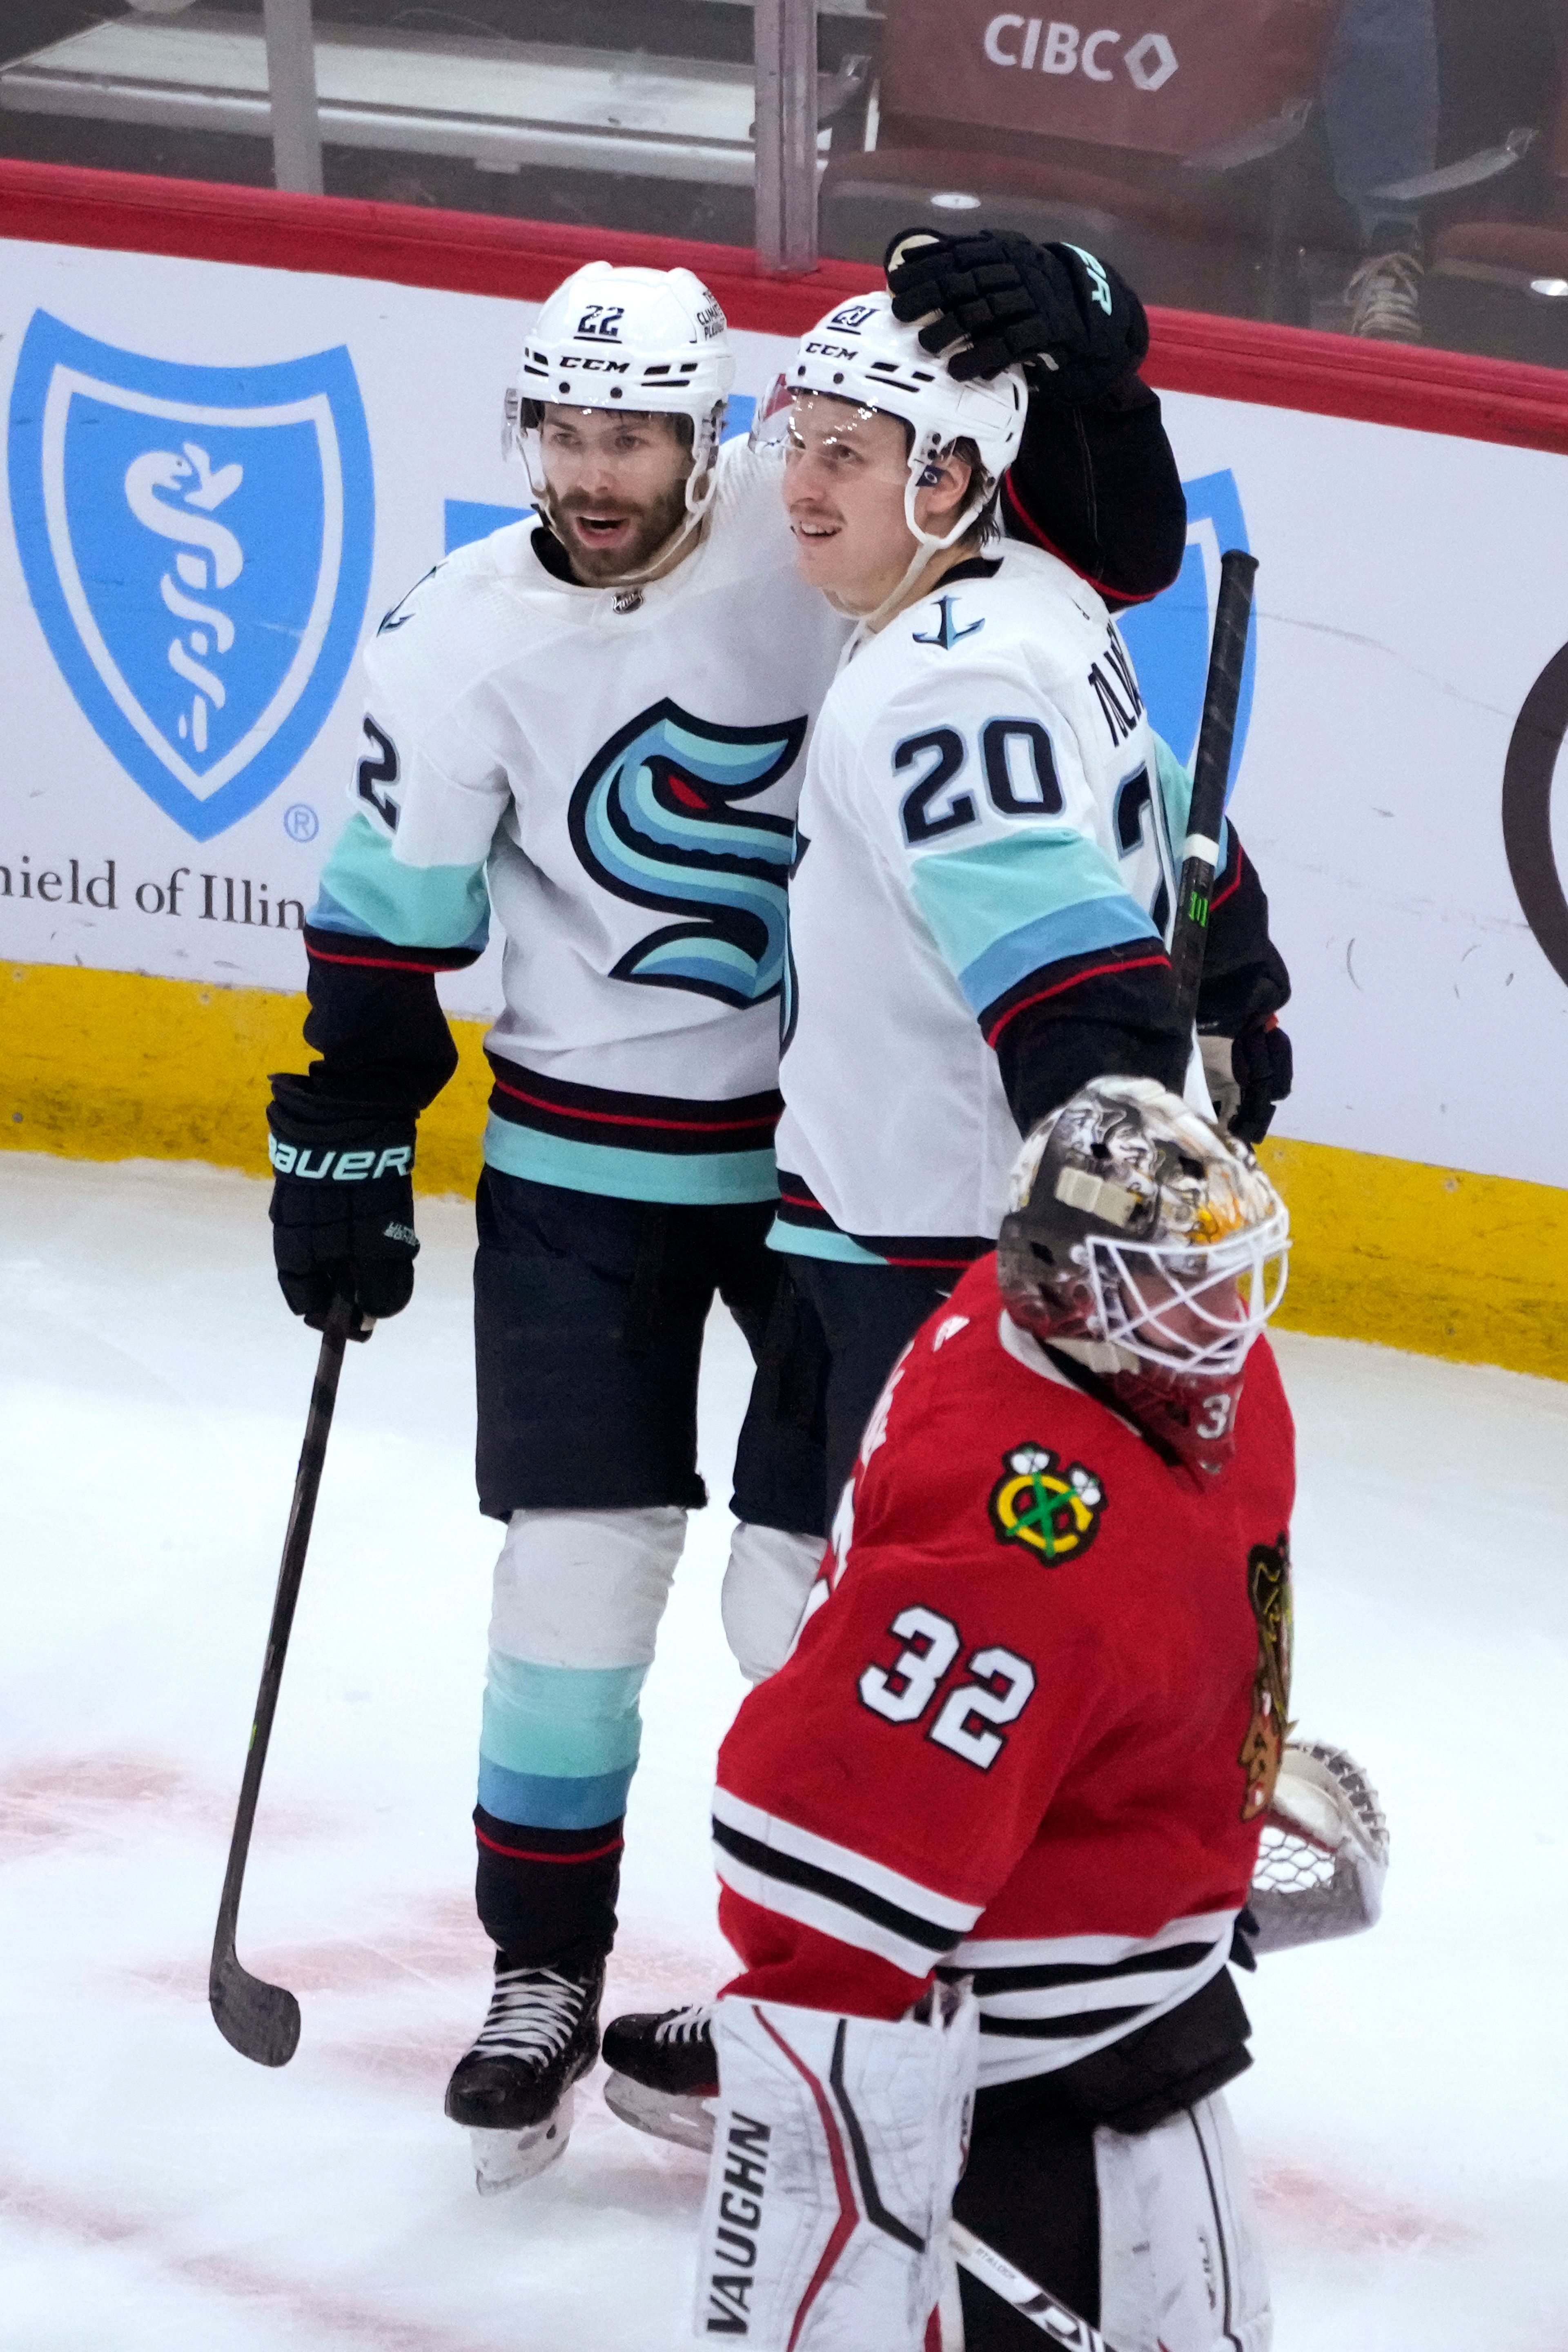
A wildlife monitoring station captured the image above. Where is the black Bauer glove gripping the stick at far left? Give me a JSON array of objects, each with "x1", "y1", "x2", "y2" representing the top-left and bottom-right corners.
[{"x1": 268, "y1": 1077, "x2": 419, "y2": 1338}]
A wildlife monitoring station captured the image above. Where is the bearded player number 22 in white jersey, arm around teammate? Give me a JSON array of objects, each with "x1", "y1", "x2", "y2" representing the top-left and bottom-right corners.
[{"x1": 270, "y1": 240, "x2": 1183, "y2": 2187}]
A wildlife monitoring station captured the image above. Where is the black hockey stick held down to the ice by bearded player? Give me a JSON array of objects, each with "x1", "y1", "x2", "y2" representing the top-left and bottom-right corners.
[{"x1": 207, "y1": 1294, "x2": 369, "y2": 2065}]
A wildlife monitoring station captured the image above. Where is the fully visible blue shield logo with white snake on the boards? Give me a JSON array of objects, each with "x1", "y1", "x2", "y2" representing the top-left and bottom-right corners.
[{"x1": 9, "y1": 310, "x2": 374, "y2": 842}]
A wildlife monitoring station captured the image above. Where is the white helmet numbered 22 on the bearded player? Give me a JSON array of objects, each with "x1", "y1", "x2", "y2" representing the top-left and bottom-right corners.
[{"x1": 501, "y1": 261, "x2": 736, "y2": 515}]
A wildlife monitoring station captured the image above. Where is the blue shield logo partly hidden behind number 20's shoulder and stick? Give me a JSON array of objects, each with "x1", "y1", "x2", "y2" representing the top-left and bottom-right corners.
[{"x1": 1117, "y1": 470, "x2": 1258, "y2": 793}]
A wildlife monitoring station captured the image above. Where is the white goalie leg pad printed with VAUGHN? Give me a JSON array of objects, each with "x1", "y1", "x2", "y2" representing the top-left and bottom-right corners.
[{"x1": 693, "y1": 1987, "x2": 973, "y2": 2352}]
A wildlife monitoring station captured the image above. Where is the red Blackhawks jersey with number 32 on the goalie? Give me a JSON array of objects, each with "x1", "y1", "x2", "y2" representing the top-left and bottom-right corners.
[{"x1": 715, "y1": 1258, "x2": 1295, "y2": 2082}]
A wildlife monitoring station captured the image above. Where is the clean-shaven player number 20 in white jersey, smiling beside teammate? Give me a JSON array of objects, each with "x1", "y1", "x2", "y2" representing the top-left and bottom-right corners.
[{"x1": 724, "y1": 296, "x2": 1288, "y2": 1571}]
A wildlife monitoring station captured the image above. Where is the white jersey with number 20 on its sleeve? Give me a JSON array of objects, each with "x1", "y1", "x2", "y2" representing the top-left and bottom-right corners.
[{"x1": 773, "y1": 541, "x2": 1189, "y2": 1263}]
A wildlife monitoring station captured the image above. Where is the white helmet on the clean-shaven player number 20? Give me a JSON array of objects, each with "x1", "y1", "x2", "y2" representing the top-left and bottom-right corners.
[{"x1": 752, "y1": 294, "x2": 1030, "y2": 564}]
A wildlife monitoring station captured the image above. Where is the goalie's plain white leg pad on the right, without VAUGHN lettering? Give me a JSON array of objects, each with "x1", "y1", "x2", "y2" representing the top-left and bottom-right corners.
[{"x1": 1096, "y1": 2096, "x2": 1274, "y2": 2352}]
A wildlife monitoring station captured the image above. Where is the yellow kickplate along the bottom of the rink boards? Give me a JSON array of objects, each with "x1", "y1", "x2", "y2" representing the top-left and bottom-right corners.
[{"x1": 0, "y1": 964, "x2": 1568, "y2": 1381}]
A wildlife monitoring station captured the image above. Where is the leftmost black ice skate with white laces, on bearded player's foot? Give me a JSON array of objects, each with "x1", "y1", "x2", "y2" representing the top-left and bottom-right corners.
[{"x1": 447, "y1": 1952, "x2": 604, "y2": 2197}]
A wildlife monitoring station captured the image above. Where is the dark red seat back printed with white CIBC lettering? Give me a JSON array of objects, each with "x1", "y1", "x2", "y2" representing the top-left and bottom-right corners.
[{"x1": 882, "y1": 0, "x2": 1338, "y2": 160}]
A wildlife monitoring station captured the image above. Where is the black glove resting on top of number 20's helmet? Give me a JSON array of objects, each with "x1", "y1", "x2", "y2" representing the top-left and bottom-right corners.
[{"x1": 886, "y1": 228, "x2": 1149, "y2": 402}]
